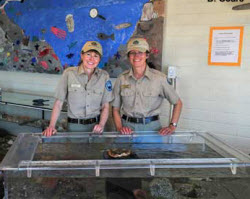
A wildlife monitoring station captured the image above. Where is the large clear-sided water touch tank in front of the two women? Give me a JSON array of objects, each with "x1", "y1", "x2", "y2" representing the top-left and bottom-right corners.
[{"x1": 0, "y1": 132, "x2": 250, "y2": 199}]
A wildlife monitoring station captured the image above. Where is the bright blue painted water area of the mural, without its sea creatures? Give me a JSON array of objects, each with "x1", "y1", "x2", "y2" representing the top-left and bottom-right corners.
[{"x1": 5, "y1": 0, "x2": 148, "y2": 68}]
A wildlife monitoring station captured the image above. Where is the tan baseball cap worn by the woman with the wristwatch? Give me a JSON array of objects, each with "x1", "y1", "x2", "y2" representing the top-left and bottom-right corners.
[{"x1": 127, "y1": 38, "x2": 149, "y2": 53}]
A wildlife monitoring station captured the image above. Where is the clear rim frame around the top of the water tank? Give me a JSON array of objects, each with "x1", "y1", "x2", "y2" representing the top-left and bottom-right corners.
[{"x1": 0, "y1": 131, "x2": 250, "y2": 178}]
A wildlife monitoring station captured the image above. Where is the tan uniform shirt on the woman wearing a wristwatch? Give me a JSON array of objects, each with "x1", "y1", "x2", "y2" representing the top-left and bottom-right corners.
[{"x1": 112, "y1": 66, "x2": 179, "y2": 117}]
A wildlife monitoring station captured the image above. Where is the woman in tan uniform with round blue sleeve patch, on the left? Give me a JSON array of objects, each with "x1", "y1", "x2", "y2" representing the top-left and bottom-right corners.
[{"x1": 43, "y1": 41, "x2": 112, "y2": 136}]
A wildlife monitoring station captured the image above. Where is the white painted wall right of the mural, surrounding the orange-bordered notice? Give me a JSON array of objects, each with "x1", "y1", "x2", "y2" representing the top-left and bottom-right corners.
[{"x1": 163, "y1": 0, "x2": 250, "y2": 151}]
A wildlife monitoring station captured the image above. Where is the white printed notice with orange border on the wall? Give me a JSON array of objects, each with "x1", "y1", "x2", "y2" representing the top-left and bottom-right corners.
[{"x1": 208, "y1": 26, "x2": 243, "y2": 66}]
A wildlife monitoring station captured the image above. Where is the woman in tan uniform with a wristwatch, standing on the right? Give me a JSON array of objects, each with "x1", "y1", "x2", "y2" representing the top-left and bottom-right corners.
[{"x1": 112, "y1": 38, "x2": 182, "y2": 135}]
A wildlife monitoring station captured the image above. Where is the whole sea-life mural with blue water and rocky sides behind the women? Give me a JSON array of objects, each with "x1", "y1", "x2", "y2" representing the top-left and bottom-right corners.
[{"x1": 0, "y1": 0, "x2": 165, "y2": 77}]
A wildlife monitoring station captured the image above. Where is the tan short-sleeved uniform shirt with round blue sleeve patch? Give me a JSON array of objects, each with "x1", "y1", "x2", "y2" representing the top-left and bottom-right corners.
[{"x1": 55, "y1": 67, "x2": 112, "y2": 119}]
